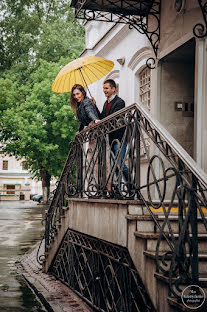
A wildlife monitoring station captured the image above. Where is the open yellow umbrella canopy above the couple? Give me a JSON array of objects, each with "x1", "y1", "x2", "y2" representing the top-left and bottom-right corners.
[{"x1": 52, "y1": 56, "x2": 114, "y2": 93}]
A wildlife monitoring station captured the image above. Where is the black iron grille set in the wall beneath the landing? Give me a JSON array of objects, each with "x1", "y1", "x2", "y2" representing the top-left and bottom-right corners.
[{"x1": 50, "y1": 229, "x2": 155, "y2": 312}]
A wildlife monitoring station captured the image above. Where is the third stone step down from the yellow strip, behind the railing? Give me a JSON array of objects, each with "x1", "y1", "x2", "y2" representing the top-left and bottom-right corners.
[{"x1": 143, "y1": 251, "x2": 207, "y2": 274}]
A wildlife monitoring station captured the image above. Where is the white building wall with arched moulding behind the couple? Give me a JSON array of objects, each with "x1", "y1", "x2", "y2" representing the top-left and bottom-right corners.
[{"x1": 82, "y1": 21, "x2": 153, "y2": 110}]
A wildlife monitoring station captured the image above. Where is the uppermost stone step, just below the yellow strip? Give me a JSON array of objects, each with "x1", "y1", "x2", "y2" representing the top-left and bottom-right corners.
[{"x1": 126, "y1": 215, "x2": 207, "y2": 234}]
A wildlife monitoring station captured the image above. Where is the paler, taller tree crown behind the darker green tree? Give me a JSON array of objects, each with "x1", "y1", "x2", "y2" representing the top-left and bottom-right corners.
[{"x1": 0, "y1": 0, "x2": 83, "y2": 72}]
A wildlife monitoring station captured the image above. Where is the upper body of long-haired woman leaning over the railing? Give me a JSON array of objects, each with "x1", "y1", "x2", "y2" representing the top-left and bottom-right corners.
[{"x1": 70, "y1": 84, "x2": 100, "y2": 131}]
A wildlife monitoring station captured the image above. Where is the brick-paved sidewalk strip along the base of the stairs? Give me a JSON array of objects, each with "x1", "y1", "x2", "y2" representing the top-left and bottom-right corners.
[{"x1": 16, "y1": 247, "x2": 92, "y2": 312}]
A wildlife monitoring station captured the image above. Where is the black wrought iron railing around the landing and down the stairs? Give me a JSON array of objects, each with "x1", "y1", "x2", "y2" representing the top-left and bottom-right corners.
[{"x1": 45, "y1": 104, "x2": 207, "y2": 297}]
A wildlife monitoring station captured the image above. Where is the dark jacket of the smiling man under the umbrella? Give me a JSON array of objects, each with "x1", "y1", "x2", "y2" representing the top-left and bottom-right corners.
[{"x1": 101, "y1": 95, "x2": 126, "y2": 144}]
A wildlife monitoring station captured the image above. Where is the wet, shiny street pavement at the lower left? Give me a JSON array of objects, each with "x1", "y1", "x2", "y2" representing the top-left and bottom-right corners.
[{"x1": 0, "y1": 201, "x2": 46, "y2": 312}]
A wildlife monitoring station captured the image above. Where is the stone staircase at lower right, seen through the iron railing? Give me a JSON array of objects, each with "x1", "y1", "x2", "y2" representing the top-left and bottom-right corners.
[{"x1": 126, "y1": 209, "x2": 207, "y2": 312}]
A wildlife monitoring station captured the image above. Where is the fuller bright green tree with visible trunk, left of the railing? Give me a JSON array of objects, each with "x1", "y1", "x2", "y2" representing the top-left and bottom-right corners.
[{"x1": 0, "y1": 60, "x2": 78, "y2": 201}]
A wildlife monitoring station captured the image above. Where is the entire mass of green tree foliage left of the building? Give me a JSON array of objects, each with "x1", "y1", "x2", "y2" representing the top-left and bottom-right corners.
[{"x1": 0, "y1": 0, "x2": 84, "y2": 185}]
